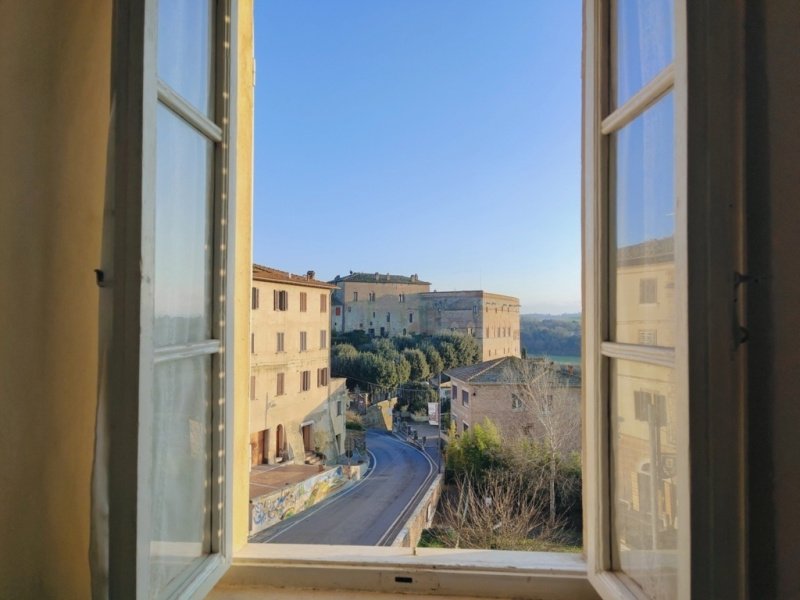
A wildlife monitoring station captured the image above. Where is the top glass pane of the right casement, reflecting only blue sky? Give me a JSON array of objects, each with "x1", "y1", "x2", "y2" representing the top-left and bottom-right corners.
[{"x1": 615, "y1": 0, "x2": 674, "y2": 106}]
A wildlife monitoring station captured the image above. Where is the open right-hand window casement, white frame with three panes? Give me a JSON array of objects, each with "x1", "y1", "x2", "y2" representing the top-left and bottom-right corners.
[{"x1": 583, "y1": 0, "x2": 692, "y2": 600}]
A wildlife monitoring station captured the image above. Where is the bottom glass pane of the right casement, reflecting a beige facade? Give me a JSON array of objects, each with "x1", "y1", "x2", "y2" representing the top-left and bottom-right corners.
[{"x1": 611, "y1": 360, "x2": 679, "y2": 599}]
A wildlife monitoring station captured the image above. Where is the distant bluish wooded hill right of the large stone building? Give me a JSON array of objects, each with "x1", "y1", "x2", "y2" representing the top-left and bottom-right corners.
[{"x1": 520, "y1": 313, "x2": 581, "y2": 356}]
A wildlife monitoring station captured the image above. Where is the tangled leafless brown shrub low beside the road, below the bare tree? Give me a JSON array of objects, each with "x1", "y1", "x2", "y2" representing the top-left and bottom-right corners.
[{"x1": 438, "y1": 470, "x2": 560, "y2": 550}]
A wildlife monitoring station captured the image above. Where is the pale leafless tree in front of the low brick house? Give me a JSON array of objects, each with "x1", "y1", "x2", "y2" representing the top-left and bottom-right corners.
[{"x1": 501, "y1": 359, "x2": 581, "y2": 527}]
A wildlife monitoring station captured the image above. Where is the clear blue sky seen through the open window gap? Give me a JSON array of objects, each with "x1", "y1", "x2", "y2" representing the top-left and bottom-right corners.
[{"x1": 253, "y1": 0, "x2": 581, "y2": 313}]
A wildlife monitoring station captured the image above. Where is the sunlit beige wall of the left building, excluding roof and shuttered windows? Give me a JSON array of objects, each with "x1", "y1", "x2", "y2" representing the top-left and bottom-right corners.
[{"x1": 249, "y1": 280, "x2": 345, "y2": 463}]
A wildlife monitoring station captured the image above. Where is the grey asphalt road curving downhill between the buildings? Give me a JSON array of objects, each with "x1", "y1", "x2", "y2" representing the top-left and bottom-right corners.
[{"x1": 250, "y1": 431, "x2": 436, "y2": 546}]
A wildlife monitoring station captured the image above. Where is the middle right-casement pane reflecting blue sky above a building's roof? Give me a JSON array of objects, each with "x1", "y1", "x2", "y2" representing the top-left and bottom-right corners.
[{"x1": 611, "y1": 93, "x2": 675, "y2": 347}]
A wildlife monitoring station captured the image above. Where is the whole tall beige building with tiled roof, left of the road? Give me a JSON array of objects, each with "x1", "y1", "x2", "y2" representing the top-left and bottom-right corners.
[{"x1": 250, "y1": 265, "x2": 347, "y2": 465}]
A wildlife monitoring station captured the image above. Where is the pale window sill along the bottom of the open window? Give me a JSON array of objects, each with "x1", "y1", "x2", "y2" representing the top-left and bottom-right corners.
[{"x1": 209, "y1": 544, "x2": 598, "y2": 600}]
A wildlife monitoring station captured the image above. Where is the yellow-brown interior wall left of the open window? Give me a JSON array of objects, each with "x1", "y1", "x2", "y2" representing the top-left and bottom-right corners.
[{"x1": 0, "y1": 0, "x2": 112, "y2": 598}]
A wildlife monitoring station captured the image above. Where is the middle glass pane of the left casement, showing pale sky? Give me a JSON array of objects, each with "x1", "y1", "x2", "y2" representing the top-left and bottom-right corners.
[{"x1": 154, "y1": 105, "x2": 214, "y2": 347}]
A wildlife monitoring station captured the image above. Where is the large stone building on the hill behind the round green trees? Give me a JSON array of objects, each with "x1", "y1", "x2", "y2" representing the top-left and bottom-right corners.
[{"x1": 330, "y1": 273, "x2": 520, "y2": 360}]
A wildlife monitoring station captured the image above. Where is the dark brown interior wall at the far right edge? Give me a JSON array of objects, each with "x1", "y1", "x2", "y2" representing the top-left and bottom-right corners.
[{"x1": 746, "y1": 0, "x2": 800, "y2": 598}]
